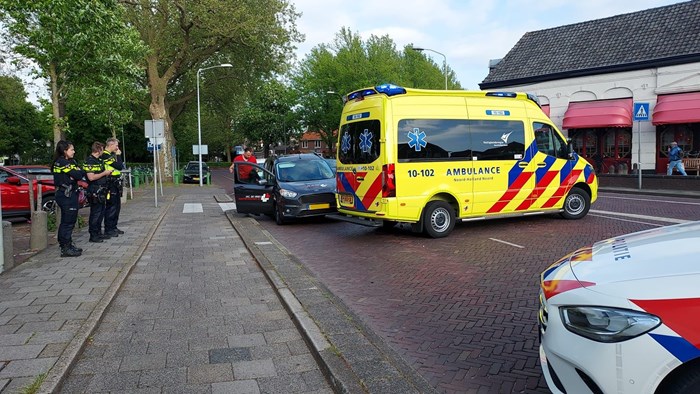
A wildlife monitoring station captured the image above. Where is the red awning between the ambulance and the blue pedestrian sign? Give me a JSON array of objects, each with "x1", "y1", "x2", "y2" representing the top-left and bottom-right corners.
[{"x1": 562, "y1": 98, "x2": 632, "y2": 129}]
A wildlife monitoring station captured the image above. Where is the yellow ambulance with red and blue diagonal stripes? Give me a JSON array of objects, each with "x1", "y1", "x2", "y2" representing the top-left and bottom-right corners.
[{"x1": 336, "y1": 85, "x2": 598, "y2": 238}]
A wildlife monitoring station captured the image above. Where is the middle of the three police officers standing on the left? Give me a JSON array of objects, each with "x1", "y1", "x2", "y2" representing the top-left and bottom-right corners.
[{"x1": 83, "y1": 142, "x2": 112, "y2": 242}]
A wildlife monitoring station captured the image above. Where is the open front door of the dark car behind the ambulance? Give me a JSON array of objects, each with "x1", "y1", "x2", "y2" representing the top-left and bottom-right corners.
[{"x1": 233, "y1": 162, "x2": 276, "y2": 215}]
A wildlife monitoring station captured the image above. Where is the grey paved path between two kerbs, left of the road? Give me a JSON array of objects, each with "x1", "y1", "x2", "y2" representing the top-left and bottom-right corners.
[{"x1": 63, "y1": 188, "x2": 332, "y2": 393}]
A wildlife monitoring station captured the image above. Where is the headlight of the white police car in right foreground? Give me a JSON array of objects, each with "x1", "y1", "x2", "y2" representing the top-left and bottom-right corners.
[{"x1": 559, "y1": 306, "x2": 661, "y2": 343}]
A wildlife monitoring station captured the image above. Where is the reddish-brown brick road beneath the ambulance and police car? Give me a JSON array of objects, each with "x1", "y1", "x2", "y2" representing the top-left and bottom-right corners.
[{"x1": 209, "y1": 171, "x2": 700, "y2": 393}]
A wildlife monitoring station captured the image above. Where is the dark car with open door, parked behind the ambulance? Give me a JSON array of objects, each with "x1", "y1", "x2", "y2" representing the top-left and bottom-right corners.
[{"x1": 234, "y1": 154, "x2": 336, "y2": 224}]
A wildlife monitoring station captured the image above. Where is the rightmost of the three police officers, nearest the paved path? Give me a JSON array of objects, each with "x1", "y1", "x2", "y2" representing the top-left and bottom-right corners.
[{"x1": 100, "y1": 137, "x2": 124, "y2": 237}]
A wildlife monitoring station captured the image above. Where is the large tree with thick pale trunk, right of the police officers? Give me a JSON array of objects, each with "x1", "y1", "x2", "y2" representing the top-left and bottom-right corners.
[{"x1": 121, "y1": 0, "x2": 300, "y2": 177}]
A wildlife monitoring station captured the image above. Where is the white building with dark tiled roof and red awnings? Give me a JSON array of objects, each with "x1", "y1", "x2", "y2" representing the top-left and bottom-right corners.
[{"x1": 479, "y1": 0, "x2": 700, "y2": 174}]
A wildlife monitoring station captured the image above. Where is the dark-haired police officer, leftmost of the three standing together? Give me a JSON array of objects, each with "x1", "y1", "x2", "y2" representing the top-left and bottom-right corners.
[{"x1": 52, "y1": 140, "x2": 85, "y2": 257}]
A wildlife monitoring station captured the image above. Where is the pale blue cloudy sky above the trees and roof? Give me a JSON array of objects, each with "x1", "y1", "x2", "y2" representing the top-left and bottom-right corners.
[{"x1": 291, "y1": 0, "x2": 683, "y2": 90}]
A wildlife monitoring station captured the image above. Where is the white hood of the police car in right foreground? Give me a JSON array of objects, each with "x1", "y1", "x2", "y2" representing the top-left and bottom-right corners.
[{"x1": 569, "y1": 221, "x2": 700, "y2": 298}]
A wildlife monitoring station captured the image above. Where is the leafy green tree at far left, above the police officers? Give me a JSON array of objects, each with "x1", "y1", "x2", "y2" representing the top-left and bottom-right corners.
[{"x1": 0, "y1": 0, "x2": 144, "y2": 142}]
